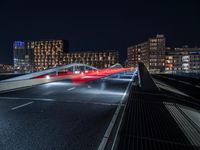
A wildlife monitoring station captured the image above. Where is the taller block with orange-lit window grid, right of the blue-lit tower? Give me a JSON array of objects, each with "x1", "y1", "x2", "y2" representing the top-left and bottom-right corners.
[{"x1": 27, "y1": 40, "x2": 68, "y2": 70}]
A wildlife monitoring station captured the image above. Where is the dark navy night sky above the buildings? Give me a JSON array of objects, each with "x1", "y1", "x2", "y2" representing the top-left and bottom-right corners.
[{"x1": 0, "y1": 0, "x2": 200, "y2": 63}]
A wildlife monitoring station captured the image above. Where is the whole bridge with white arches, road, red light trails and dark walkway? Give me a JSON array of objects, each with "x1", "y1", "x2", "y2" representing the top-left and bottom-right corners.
[{"x1": 0, "y1": 63, "x2": 200, "y2": 150}]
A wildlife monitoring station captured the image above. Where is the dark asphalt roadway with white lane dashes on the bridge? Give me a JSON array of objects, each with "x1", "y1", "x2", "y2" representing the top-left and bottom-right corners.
[{"x1": 0, "y1": 72, "x2": 133, "y2": 150}]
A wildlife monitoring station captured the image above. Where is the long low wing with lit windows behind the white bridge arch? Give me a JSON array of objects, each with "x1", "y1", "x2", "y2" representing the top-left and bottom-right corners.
[{"x1": 63, "y1": 50, "x2": 118, "y2": 69}]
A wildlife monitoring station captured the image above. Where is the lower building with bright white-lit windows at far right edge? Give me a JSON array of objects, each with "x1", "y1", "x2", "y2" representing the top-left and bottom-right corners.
[{"x1": 165, "y1": 46, "x2": 200, "y2": 73}]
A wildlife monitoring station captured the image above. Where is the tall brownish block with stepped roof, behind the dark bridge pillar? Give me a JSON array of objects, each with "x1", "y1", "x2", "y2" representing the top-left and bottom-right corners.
[{"x1": 128, "y1": 35, "x2": 165, "y2": 72}]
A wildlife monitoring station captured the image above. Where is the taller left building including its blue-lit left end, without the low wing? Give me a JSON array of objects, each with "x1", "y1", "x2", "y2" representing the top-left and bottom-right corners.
[{"x1": 13, "y1": 40, "x2": 68, "y2": 72}]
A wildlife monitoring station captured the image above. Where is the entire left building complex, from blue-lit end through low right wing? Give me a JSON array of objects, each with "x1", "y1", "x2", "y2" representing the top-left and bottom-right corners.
[{"x1": 13, "y1": 40, "x2": 119, "y2": 72}]
